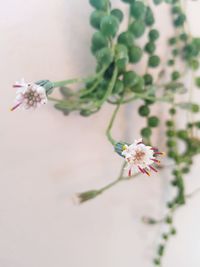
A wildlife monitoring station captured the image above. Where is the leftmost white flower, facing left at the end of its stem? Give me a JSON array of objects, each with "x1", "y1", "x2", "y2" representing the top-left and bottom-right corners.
[{"x1": 11, "y1": 79, "x2": 47, "y2": 111}]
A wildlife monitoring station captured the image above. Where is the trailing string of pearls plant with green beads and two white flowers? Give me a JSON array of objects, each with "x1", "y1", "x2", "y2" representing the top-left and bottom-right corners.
[{"x1": 11, "y1": 0, "x2": 200, "y2": 266}]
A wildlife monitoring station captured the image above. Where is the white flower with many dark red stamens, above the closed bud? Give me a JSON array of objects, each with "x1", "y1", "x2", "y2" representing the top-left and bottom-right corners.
[{"x1": 122, "y1": 139, "x2": 163, "y2": 176}]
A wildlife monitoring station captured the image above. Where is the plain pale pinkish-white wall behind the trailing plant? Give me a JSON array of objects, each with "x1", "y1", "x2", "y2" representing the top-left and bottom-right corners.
[{"x1": 0, "y1": 0, "x2": 200, "y2": 267}]
